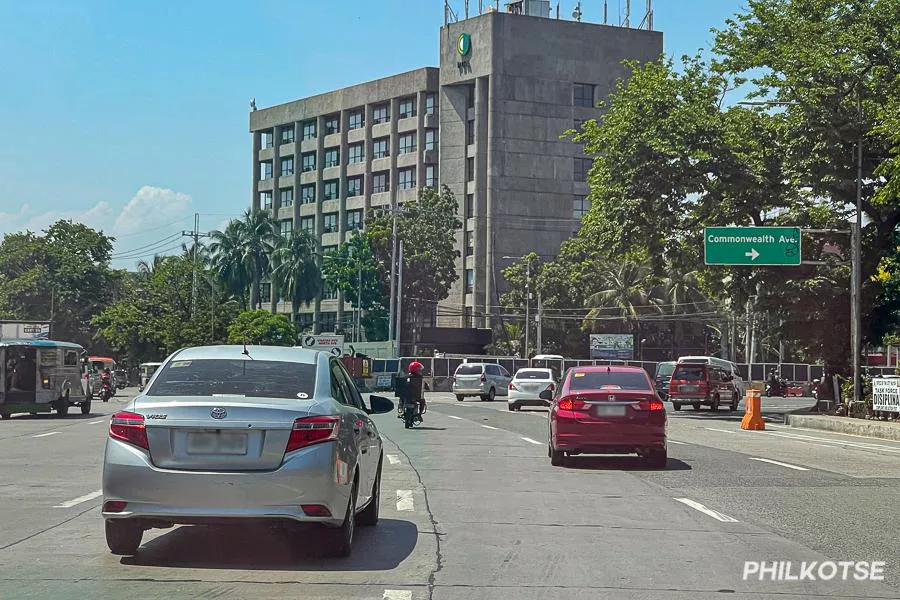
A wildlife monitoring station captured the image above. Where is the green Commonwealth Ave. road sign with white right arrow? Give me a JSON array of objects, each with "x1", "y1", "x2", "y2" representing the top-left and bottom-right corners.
[{"x1": 703, "y1": 227, "x2": 801, "y2": 266}]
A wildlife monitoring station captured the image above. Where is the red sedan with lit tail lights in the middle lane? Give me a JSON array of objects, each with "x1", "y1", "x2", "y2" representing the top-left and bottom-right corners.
[{"x1": 542, "y1": 366, "x2": 668, "y2": 468}]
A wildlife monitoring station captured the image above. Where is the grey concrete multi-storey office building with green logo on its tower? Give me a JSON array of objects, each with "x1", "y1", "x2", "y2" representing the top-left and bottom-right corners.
[{"x1": 250, "y1": 0, "x2": 662, "y2": 332}]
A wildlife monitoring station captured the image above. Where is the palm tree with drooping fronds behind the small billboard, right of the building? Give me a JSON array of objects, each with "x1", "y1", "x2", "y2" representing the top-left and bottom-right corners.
[{"x1": 583, "y1": 261, "x2": 655, "y2": 333}]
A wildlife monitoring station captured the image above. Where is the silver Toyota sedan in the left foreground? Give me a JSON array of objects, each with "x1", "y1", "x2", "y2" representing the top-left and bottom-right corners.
[{"x1": 102, "y1": 346, "x2": 394, "y2": 556}]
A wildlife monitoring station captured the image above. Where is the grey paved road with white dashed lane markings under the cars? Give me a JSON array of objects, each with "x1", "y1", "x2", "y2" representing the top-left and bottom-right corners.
[{"x1": 0, "y1": 386, "x2": 900, "y2": 600}]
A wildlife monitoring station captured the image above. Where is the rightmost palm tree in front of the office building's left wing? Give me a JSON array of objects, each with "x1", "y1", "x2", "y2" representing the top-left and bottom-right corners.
[{"x1": 270, "y1": 231, "x2": 322, "y2": 322}]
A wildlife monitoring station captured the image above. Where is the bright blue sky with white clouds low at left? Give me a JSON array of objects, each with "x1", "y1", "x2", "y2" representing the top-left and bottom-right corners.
[{"x1": 0, "y1": 0, "x2": 744, "y2": 267}]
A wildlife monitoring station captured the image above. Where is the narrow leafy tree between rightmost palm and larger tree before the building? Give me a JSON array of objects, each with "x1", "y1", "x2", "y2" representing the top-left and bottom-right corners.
[{"x1": 322, "y1": 232, "x2": 390, "y2": 341}]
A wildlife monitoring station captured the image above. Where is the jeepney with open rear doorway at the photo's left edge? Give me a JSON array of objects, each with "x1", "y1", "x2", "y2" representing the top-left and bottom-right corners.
[{"x1": 0, "y1": 340, "x2": 91, "y2": 419}]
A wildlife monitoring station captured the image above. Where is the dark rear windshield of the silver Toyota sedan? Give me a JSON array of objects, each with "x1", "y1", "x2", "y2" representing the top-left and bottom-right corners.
[{"x1": 147, "y1": 359, "x2": 316, "y2": 400}]
